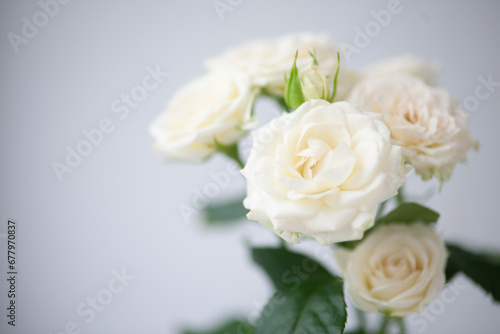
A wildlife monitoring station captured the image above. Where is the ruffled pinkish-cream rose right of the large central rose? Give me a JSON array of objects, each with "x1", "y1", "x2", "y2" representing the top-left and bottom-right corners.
[{"x1": 348, "y1": 76, "x2": 478, "y2": 182}]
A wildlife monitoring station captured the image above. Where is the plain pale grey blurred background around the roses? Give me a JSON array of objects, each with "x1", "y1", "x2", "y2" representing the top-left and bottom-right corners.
[{"x1": 0, "y1": 0, "x2": 500, "y2": 334}]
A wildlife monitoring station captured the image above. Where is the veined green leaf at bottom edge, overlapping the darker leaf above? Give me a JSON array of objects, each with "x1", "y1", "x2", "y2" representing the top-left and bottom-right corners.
[{"x1": 255, "y1": 278, "x2": 347, "y2": 334}]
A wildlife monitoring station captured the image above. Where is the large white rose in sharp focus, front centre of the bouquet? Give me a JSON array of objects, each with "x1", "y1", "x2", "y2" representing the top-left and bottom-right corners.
[{"x1": 242, "y1": 100, "x2": 406, "y2": 244}]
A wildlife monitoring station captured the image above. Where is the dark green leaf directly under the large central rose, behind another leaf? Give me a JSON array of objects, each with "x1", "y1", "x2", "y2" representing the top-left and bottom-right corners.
[{"x1": 252, "y1": 248, "x2": 332, "y2": 290}]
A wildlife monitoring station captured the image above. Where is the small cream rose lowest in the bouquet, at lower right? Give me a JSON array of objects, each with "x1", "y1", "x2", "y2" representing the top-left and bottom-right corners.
[{"x1": 334, "y1": 223, "x2": 447, "y2": 316}]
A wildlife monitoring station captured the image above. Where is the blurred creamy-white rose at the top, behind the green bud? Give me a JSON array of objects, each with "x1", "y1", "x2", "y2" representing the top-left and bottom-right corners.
[{"x1": 206, "y1": 33, "x2": 358, "y2": 100}]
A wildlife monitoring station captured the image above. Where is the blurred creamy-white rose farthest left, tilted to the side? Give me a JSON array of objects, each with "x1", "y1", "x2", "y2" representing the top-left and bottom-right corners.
[{"x1": 150, "y1": 72, "x2": 257, "y2": 162}]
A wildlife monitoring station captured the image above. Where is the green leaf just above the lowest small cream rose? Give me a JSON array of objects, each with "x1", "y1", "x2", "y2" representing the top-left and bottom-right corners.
[{"x1": 377, "y1": 202, "x2": 439, "y2": 224}]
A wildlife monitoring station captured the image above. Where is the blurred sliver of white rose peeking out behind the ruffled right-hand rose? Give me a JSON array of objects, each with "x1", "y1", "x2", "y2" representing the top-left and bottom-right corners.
[{"x1": 364, "y1": 55, "x2": 441, "y2": 84}]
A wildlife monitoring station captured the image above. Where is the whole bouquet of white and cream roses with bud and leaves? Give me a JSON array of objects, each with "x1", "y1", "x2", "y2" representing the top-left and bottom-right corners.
[{"x1": 151, "y1": 34, "x2": 500, "y2": 333}]
